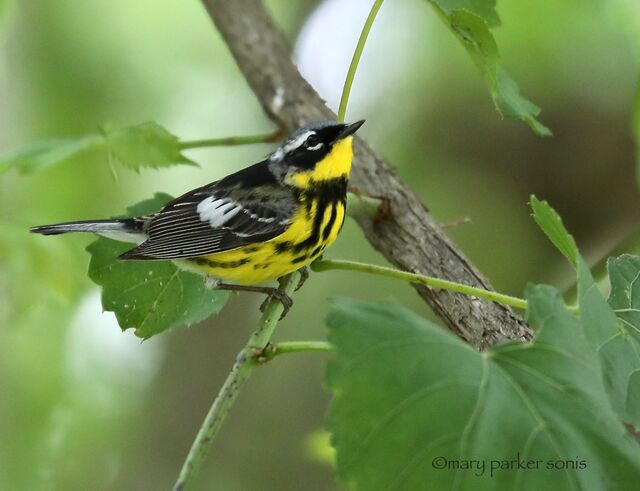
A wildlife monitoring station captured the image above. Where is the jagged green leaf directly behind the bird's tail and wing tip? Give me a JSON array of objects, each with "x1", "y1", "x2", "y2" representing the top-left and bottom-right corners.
[{"x1": 87, "y1": 193, "x2": 229, "y2": 339}]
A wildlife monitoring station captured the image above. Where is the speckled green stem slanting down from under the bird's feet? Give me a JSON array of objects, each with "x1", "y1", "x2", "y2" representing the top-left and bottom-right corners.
[{"x1": 173, "y1": 273, "x2": 300, "y2": 491}]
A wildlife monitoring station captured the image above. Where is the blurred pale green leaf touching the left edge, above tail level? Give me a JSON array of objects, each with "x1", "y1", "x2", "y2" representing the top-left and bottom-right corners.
[{"x1": 0, "y1": 135, "x2": 104, "y2": 174}]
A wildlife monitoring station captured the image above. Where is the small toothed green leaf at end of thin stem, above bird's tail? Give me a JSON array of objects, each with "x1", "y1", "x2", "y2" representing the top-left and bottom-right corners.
[{"x1": 103, "y1": 122, "x2": 197, "y2": 171}]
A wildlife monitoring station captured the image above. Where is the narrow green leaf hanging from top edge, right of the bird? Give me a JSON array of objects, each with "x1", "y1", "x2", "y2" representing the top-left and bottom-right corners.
[{"x1": 429, "y1": 0, "x2": 551, "y2": 135}]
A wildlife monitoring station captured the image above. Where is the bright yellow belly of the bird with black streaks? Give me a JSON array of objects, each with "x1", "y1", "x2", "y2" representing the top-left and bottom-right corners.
[{"x1": 185, "y1": 201, "x2": 345, "y2": 285}]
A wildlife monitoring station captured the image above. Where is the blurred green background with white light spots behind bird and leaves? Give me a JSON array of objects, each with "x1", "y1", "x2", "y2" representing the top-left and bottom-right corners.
[{"x1": 0, "y1": 0, "x2": 640, "y2": 491}]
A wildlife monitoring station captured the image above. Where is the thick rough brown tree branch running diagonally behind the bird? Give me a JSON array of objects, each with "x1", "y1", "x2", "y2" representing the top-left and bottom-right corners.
[{"x1": 203, "y1": 0, "x2": 532, "y2": 349}]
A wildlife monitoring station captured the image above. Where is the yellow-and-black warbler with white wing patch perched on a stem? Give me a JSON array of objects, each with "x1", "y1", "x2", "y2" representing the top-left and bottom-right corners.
[{"x1": 31, "y1": 120, "x2": 364, "y2": 316}]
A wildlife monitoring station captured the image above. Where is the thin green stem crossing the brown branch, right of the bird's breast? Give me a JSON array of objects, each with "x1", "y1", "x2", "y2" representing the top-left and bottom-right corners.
[{"x1": 311, "y1": 259, "x2": 528, "y2": 309}]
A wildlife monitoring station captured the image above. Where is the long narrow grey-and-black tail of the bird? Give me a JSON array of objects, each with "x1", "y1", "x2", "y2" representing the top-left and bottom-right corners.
[{"x1": 31, "y1": 218, "x2": 146, "y2": 242}]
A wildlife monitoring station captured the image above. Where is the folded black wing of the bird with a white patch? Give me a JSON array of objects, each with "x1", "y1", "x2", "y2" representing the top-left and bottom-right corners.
[{"x1": 120, "y1": 161, "x2": 296, "y2": 259}]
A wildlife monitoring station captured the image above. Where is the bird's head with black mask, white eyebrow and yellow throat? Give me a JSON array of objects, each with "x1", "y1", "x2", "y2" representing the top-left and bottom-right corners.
[{"x1": 269, "y1": 120, "x2": 364, "y2": 187}]
